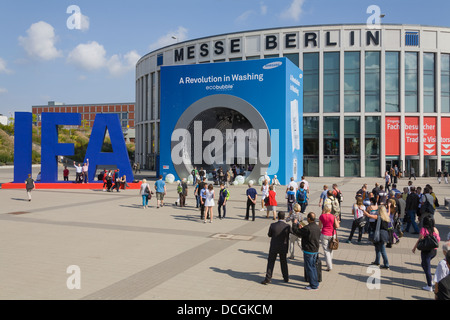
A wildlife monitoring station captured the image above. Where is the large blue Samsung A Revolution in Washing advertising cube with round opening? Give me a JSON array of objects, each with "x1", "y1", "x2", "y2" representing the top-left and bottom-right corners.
[{"x1": 158, "y1": 58, "x2": 303, "y2": 184}]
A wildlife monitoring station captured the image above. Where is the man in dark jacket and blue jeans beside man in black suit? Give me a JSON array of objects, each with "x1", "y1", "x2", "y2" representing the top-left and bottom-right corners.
[{"x1": 292, "y1": 212, "x2": 320, "y2": 290}]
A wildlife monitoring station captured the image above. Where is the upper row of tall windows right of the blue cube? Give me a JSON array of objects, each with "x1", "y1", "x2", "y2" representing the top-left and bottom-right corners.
[{"x1": 303, "y1": 51, "x2": 450, "y2": 113}]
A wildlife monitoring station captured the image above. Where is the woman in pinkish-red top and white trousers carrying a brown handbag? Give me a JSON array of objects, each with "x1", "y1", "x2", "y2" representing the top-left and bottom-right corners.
[{"x1": 319, "y1": 204, "x2": 339, "y2": 271}]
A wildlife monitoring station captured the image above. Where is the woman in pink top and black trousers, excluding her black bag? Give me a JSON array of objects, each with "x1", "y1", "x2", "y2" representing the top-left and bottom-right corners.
[{"x1": 412, "y1": 216, "x2": 441, "y2": 291}]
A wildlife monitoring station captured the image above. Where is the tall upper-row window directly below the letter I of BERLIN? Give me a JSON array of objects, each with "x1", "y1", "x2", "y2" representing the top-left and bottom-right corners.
[{"x1": 344, "y1": 52, "x2": 361, "y2": 112}]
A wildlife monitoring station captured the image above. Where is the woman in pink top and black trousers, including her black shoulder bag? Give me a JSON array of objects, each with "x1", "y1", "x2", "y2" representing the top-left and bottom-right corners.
[{"x1": 412, "y1": 216, "x2": 441, "y2": 291}]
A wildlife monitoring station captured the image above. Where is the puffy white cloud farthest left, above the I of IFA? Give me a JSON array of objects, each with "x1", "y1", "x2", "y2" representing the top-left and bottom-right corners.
[{"x1": 19, "y1": 21, "x2": 62, "y2": 60}]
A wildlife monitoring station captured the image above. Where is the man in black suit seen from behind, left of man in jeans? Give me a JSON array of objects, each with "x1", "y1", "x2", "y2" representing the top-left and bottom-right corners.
[{"x1": 261, "y1": 211, "x2": 291, "y2": 285}]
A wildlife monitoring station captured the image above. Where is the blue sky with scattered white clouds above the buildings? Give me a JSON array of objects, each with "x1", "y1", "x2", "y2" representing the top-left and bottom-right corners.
[{"x1": 0, "y1": 0, "x2": 450, "y2": 117}]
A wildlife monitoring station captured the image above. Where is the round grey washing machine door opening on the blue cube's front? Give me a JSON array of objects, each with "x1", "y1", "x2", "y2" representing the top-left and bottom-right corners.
[{"x1": 171, "y1": 94, "x2": 271, "y2": 181}]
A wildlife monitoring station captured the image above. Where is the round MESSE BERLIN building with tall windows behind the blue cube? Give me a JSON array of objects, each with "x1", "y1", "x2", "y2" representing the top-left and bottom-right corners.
[{"x1": 135, "y1": 24, "x2": 450, "y2": 177}]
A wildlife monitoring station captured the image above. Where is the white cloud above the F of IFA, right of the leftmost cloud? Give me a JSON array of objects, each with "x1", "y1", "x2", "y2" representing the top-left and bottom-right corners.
[{"x1": 67, "y1": 41, "x2": 107, "y2": 71}]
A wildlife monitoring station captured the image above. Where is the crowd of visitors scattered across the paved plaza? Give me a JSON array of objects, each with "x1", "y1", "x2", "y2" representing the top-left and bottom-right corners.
[{"x1": 25, "y1": 161, "x2": 450, "y2": 299}]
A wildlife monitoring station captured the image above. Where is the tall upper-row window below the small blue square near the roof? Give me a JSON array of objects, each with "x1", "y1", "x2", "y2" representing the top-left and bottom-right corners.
[{"x1": 405, "y1": 52, "x2": 419, "y2": 112}]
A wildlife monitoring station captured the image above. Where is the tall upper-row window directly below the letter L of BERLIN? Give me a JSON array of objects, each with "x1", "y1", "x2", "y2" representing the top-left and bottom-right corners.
[{"x1": 323, "y1": 52, "x2": 340, "y2": 112}]
